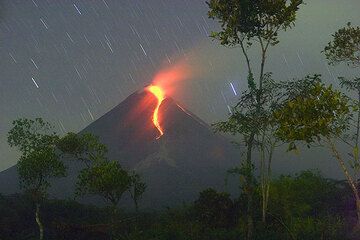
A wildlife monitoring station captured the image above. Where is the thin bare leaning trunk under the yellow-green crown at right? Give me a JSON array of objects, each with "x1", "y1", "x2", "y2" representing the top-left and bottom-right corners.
[{"x1": 327, "y1": 139, "x2": 360, "y2": 228}]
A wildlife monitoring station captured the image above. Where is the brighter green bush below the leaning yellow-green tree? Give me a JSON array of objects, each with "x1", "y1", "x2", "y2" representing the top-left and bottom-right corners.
[{"x1": 270, "y1": 171, "x2": 341, "y2": 218}]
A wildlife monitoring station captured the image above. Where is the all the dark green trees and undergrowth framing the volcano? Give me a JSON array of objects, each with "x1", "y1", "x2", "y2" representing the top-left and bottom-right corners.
[{"x1": 0, "y1": 0, "x2": 360, "y2": 240}]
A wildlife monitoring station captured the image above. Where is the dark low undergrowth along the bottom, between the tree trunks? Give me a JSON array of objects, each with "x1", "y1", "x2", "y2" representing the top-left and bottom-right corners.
[{"x1": 0, "y1": 171, "x2": 357, "y2": 240}]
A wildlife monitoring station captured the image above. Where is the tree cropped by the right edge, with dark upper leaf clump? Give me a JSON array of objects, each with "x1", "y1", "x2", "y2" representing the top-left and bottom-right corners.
[{"x1": 323, "y1": 23, "x2": 360, "y2": 226}]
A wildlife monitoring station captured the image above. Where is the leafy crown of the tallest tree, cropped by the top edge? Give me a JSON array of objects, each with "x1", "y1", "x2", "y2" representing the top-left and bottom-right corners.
[{"x1": 207, "y1": 0, "x2": 303, "y2": 46}]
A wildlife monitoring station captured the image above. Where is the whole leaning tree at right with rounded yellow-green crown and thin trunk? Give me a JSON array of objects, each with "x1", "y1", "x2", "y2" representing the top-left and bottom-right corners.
[{"x1": 275, "y1": 76, "x2": 360, "y2": 227}]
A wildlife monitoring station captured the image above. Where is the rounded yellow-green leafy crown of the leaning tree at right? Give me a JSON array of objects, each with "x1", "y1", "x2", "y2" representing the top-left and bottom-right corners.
[{"x1": 274, "y1": 76, "x2": 351, "y2": 144}]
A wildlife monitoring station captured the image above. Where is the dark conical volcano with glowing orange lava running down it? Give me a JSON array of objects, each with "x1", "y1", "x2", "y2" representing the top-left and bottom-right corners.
[{"x1": 0, "y1": 87, "x2": 240, "y2": 208}]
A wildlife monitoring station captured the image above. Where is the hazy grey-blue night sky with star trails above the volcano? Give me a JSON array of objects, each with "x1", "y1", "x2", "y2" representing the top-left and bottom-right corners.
[{"x1": 0, "y1": 0, "x2": 360, "y2": 174}]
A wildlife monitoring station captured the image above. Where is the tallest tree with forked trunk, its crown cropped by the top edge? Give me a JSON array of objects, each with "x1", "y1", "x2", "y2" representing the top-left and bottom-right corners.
[{"x1": 207, "y1": 0, "x2": 303, "y2": 236}]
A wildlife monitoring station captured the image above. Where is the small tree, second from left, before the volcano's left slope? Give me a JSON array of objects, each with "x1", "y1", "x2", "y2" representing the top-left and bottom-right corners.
[{"x1": 57, "y1": 133, "x2": 139, "y2": 236}]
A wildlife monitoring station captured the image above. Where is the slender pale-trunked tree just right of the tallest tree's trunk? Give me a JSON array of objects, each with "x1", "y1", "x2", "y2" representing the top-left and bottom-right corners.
[{"x1": 214, "y1": 74, "x2": 282, "y2": 222}]
